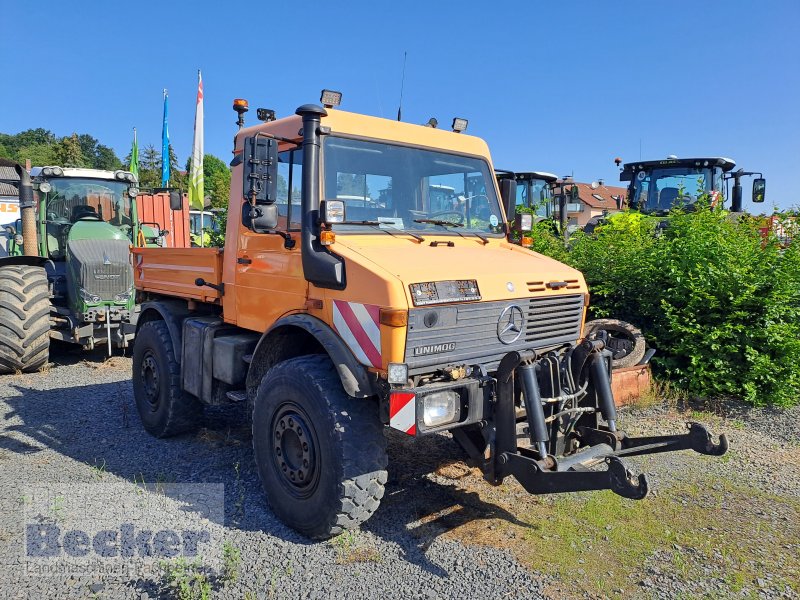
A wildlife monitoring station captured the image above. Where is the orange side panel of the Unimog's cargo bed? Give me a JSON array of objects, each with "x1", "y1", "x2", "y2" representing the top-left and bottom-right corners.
[{"x1": 131, "y1": 248, "x2": 222, "y2": 302}]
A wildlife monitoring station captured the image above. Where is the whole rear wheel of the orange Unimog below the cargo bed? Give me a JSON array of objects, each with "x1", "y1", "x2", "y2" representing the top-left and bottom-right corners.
[{"x1": 133, "y1": 321, "x2": 203, "y2": 438}]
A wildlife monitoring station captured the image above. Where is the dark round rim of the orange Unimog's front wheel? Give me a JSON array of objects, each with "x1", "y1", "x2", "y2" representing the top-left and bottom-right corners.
[{"x1": 270, "y1": 402, "x2": 319, "y2": 498}]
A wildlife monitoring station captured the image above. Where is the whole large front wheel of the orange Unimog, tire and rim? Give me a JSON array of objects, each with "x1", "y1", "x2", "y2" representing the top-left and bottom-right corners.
[{"x1": 253, "y1": 355, "x2": 388, "y2": 540}]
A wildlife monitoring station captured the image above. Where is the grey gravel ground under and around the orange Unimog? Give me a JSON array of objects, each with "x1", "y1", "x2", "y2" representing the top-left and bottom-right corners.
[{"x1": 0, "y1": 344, "x2": 800, "y2": 599}]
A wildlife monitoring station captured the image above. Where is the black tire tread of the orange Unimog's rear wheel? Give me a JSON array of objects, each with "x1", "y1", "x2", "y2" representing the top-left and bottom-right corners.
[{"x1": 133, "y1": 320, "x2": 203, "y2": 438}]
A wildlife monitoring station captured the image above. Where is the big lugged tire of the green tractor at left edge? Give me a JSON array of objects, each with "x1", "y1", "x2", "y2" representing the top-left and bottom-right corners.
[{"x1": 0, "y1": 265, "x2": 50, "y2": 373}]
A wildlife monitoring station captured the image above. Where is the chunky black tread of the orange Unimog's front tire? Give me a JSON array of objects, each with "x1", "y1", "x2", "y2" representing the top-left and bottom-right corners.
[{"x1": 253, "y1": 354, "x2": 389, "y2": 540}]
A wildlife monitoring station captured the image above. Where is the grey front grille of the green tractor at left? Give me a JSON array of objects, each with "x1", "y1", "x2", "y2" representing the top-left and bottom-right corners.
[{"x1": 67, "y1": 240, "x2": 133, "y2": 302}]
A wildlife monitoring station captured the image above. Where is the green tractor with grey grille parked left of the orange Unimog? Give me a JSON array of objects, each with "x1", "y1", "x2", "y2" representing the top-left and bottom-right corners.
[{"x1": 0, "y1": 161, "x2": 162, "y2": 373}]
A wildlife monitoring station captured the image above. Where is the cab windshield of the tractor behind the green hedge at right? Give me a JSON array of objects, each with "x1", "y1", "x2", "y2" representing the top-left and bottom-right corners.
[{"x1": 631, "y1": 167, "x2": 721, "y2": 212}]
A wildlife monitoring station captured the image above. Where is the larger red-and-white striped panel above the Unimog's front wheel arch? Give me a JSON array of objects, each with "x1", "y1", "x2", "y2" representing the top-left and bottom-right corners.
[{"x1": 333, "y1": 300, "x2": 383, "y2": 369}]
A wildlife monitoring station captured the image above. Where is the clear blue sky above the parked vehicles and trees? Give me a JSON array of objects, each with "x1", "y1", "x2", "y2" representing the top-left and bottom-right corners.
[{"x1": 0, "y1": 0, "x2": 800, "y2": 211}]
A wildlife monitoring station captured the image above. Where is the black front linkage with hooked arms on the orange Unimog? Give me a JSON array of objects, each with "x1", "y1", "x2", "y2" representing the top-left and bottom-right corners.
[{"x1": 484, "y1": 341, "x2": 728, "y2": 500}]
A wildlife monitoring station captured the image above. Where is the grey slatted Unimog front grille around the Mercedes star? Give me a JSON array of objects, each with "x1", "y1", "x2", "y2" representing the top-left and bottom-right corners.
[{"x1": 405, "y1": 294, "x2": 584, "y2": 374}]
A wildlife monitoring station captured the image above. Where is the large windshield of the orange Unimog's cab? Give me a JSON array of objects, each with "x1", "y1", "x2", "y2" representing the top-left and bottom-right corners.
[{"x1": 323, "y1": 137, "x2": 504, "y2": 235}]
